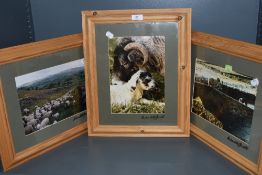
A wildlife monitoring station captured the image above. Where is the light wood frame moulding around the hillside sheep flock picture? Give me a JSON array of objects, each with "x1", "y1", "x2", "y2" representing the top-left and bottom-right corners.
[{"x1": 0, "y1": 34, "x2": 87, "y2": 171}]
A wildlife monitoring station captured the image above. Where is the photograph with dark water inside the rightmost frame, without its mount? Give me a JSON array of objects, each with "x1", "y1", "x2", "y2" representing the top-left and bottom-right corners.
[{"x1": 192, "y1": 59, "x2": 259, "y2": 143}]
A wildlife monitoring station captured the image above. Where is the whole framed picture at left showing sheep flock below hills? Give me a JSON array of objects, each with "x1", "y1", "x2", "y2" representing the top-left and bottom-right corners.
[{"x1": 0, "y1": 34, "x2": 87, "y2": 171}]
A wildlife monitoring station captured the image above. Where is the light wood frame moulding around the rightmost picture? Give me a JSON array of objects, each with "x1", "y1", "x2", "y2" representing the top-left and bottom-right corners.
[{"x1": 190, "y1": 32, "x2": 262, "y2": 175}]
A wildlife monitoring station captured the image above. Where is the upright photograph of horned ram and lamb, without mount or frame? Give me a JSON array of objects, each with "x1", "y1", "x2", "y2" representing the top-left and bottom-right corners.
[{"x1": 108, "y1": 36, "x2": 165, "y2": 114}]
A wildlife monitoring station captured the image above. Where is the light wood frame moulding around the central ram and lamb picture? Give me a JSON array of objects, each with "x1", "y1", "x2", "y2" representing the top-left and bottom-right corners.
[{"x1": 82, "y1": 9, "x2": 191, "y2": 137}]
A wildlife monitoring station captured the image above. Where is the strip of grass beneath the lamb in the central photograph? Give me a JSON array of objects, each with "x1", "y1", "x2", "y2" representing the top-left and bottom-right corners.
[{"x1": 111, "y1": 102, "x2": 165, "y2": 114}]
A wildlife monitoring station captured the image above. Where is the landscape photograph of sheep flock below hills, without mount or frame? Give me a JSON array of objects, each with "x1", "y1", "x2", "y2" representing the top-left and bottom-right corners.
[{"x1": 15, "y1": 59, "x2": 86, "y2": 135}]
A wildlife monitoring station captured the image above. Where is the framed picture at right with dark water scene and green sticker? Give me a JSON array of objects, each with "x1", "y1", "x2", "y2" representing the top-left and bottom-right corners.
[{"x1": 191, "y1": 32, "x2": 262, "y2": 174}]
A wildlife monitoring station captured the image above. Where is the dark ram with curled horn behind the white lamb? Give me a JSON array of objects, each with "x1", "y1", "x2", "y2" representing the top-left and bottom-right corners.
[{"x1": 112, "y1": 36, "x2": 165, "y2": 83}]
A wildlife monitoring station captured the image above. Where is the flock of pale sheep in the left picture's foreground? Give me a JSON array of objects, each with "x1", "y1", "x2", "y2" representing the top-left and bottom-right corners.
[{"x1": 22, "y1": 91, "x2": 76, "y2": 135}]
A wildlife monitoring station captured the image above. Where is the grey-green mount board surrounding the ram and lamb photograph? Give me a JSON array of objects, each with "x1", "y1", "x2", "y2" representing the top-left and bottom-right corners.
[{"x1": 96, "y1": 22, "x2": 178, "y2": 125}]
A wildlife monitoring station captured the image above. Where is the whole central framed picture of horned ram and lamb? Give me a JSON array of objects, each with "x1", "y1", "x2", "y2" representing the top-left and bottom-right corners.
[{"x1": 82, "y1": 9, "x2": 191, "y2": 137}]
